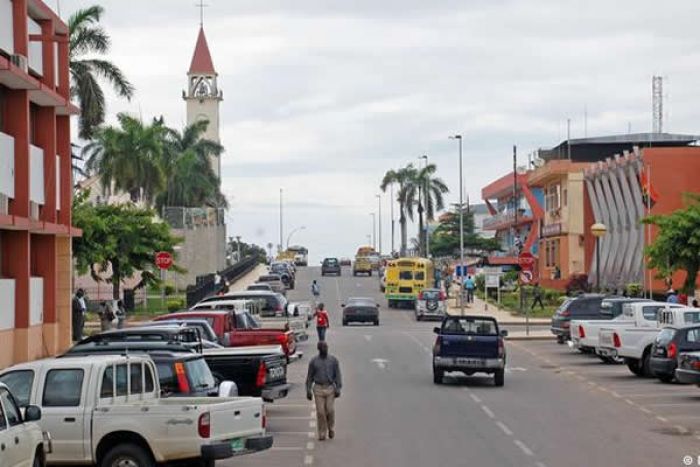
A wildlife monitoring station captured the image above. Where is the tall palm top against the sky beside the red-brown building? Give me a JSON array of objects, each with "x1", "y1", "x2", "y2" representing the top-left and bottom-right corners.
[{"x1": 68, "y1": 5, "x2": 134, "y2": 139}]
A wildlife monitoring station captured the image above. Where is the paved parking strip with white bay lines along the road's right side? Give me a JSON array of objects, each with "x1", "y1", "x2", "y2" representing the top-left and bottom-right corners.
[{"x1": 511, "y1": 341, "x2": 700, "y2": 440}]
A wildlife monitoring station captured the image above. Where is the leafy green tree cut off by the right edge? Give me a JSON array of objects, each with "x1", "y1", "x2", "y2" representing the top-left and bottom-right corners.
[{"x1": 642, "y1": 194, "x2": 700, "y2": 294}]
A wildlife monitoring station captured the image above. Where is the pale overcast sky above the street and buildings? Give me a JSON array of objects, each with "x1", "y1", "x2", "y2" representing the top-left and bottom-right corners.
[{"x1": 63, "y1": 0, "x2": 700, "y2": 260}]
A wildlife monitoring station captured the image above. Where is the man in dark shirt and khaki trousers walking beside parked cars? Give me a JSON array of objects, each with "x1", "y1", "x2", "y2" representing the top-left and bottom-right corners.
[{"x1": 306, "y1": 342, "x2": 343, "y2": 441}]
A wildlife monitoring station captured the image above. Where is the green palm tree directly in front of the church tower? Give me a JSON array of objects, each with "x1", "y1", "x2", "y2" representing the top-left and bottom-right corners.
[{"x1": 156, "y1": 120, "x2": 227, "y2": 210}]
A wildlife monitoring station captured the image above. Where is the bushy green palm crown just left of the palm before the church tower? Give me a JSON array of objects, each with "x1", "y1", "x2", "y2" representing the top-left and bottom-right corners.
[{"x1": 83, "y1": 113, "x2": 167, "y2": 206}]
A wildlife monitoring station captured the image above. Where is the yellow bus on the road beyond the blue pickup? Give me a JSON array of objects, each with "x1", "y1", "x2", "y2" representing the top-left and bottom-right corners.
[{"x1": 384, "y1": 258, "x2": 435, "y2": 308}]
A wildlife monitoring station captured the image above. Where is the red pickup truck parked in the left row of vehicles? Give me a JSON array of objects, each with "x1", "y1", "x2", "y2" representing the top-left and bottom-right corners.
[{"x1": 155, "y1": 310, "x2": 296, "y2": 358}]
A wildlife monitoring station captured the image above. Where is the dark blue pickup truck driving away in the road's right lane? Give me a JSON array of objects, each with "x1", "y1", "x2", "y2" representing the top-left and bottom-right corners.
[{"x1": 433, "y1": 316, "x2": 508, "y2": 386}]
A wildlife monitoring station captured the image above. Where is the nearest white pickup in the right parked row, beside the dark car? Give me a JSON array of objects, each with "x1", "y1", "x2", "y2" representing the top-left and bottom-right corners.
[{"x1": 596, "y1": 303, "x2": 700, "y2": 376}]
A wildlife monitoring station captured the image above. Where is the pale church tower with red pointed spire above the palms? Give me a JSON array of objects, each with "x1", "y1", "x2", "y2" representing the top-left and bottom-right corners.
[{"x1": 182, "y1": 25, "x2": 223, "y2": 178}]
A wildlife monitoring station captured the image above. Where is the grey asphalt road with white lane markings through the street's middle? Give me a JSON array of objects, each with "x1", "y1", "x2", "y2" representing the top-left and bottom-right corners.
[{"x1": 227, "y1": 268, "x2": 700, "y2": 467}]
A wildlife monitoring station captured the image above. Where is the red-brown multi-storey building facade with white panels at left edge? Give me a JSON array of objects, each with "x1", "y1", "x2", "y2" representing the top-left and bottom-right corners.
[{"x1": 0, "y1": 0, "x2": 79, "y2": 368}]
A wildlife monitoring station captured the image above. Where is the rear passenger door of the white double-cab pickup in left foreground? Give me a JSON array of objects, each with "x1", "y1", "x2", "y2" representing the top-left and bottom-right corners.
[{"x1": 37, "y1": 368, "x2": 91, "y2": 462}]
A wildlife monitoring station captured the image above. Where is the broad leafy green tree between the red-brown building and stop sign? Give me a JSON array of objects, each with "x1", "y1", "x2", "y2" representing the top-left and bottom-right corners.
[{"x1": 73, "y1": 191, "x2": 182, "y2": 300}]
